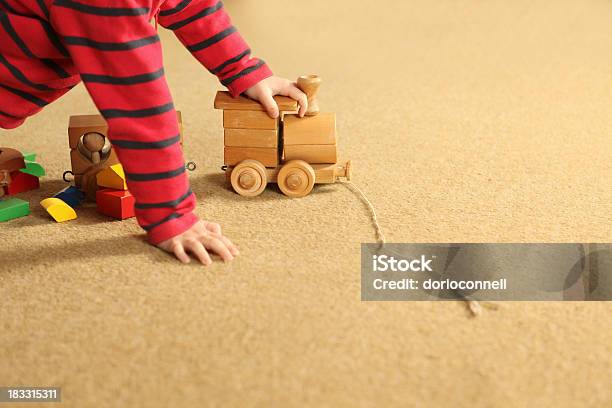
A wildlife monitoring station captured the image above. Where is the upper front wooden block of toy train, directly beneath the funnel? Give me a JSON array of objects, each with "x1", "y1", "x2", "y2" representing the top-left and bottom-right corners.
[{"x1": 283, "y1": 113, "x2": 337, "y2": 146}]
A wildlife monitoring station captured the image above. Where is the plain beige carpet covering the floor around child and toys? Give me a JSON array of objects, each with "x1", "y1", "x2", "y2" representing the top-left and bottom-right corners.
[{"x1": 0, "y1": 0, "x2": 612, "y2": 407}]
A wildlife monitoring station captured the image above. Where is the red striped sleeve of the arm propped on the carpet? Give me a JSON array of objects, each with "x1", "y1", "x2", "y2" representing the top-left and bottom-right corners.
[{"x1": 50, "y1": 0, "x2": 197, "y2": 244}]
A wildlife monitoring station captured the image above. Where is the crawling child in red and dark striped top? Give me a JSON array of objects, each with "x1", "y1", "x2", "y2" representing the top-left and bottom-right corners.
[{"x1": 0, "y1": 0, "x2": 307, "y2": 265}]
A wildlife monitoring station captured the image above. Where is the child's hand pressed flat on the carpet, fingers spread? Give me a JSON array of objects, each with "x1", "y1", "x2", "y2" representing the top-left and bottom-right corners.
[{"x1": 157, "y1": 221, "x2": 239, "y2": 266}]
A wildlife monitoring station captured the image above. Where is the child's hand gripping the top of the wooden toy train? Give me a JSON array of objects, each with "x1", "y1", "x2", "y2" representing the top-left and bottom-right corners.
[{"x1": 245, "y1": 77, "x2": 308, "y2": 119}]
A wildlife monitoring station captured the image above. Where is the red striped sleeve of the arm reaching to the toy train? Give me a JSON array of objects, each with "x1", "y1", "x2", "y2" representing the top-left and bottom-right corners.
[{"x1": 158, "y1": 0, "x2": 272, "y2": 96}]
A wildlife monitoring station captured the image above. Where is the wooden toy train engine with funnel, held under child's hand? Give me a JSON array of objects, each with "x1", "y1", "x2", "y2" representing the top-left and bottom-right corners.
[{"x1": 215, "y1": 75, "x2": 351, "y2": 197}]
